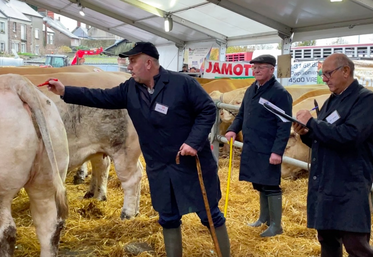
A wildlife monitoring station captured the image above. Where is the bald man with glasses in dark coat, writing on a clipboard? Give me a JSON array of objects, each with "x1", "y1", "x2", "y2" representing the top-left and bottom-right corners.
[{"x1": 293, "y1": 54, "x2": 373, "y2": 257}]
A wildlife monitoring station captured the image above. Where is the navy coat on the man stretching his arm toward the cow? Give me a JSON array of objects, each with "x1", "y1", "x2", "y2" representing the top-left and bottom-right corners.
[{"x1": 63, "y1": 67, "x2": 221, "y2": 215}]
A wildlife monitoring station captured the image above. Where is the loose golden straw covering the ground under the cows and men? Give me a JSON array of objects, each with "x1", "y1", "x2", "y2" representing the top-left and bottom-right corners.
[{"x1": 12, "y1": 155, "x2": 364, "y2": 257}]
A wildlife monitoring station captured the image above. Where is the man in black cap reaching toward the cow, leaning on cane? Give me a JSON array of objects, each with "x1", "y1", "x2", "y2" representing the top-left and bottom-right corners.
[{"x1": 45, "y1": 42, "x2": 230, "y2": 257}]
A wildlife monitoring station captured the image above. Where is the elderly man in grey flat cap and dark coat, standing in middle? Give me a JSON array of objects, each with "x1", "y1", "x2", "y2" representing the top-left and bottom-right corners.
[{"x1": 225, "y1": 55, "x2": 293, "y2": 237}]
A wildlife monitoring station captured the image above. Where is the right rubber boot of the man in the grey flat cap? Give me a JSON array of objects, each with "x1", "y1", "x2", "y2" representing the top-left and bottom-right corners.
[{"x1": 260, "y1": 195, "x2": 283, "y2": 237}]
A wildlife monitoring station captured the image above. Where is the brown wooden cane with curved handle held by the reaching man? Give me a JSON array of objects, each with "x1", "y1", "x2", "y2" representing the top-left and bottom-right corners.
[{"x1": 176, "y1": 151, "x2": 222, "y2": 257}]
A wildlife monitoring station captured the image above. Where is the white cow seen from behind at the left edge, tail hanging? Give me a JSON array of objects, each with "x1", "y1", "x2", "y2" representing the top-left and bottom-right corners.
[{"x1": 0, "y1": 74, "x2": 69, "y2": 257}]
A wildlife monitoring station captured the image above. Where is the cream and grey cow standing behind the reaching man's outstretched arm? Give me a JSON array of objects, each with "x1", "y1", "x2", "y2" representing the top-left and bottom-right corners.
[{"x1": 33, "y1": 72, "x2": 143, "y2": 219}]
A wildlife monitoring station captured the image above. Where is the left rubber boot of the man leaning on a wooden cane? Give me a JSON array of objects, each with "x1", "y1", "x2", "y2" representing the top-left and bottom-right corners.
[{"x1": 163, "y1": 227, "x2": 183, "y2": 257}]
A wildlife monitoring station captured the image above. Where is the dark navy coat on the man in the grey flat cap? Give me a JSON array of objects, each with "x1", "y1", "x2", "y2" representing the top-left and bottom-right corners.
[{"x1": 228, "y1": 77, "x2": 293, "y2": 185}]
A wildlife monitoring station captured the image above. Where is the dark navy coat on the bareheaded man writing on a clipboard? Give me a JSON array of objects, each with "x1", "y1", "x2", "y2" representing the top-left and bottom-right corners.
[{"x1": 301, "y1": 80, "x2": 373, "y2": 233}]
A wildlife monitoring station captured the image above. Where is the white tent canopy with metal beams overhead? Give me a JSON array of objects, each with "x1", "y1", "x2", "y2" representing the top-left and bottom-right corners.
[{"x1": 24, "y1": 0, "x2": 373, "y2": 46}]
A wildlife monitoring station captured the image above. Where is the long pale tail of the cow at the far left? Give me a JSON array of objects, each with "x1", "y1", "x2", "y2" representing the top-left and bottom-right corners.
[{"x1": 17, "y1": 76, "x2": 68, "y2": 219}]
